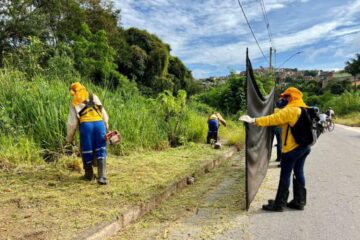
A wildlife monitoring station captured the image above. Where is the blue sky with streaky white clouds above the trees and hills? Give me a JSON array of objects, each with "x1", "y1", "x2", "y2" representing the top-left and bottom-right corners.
[{"x1": 114, "y1": 0, "x2": 360, "y2": 78}]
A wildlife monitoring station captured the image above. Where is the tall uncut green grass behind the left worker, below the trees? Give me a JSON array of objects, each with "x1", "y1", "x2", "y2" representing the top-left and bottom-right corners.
[{"x1": 0, "y1": 69, "x2": 222, "y2": 163}]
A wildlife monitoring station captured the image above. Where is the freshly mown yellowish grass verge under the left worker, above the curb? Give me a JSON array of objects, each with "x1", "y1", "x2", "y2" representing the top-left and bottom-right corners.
[{"x1": 0, "y1": 144, "x2": 228, "y2": 239}]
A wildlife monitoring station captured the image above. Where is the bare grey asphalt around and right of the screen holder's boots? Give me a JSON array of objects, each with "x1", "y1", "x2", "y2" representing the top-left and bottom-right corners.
[{"x1": 240, "y1": 125, "x2": 360, "y2": 240}]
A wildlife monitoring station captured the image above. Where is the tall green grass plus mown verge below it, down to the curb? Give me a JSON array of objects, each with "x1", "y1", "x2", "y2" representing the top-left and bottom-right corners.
[{"x1": 0, "y1": 66, "x2": 244, "y2": 239}]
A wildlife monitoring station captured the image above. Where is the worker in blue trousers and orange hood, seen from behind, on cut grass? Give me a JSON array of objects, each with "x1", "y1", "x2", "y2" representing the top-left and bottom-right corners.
[{"x1": 66, "y1": 82, "x2": 109, "y2": 185}]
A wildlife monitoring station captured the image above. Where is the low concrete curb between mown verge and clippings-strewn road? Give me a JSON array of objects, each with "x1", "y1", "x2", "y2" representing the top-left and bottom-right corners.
[{"x1": 74, "y1": 147, "x2": 238, "y2": 240}]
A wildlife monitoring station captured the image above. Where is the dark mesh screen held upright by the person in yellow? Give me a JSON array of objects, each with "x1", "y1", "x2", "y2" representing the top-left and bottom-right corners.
[{"x1": 245, "y1": 51, "x2": 274, "y2": 209}]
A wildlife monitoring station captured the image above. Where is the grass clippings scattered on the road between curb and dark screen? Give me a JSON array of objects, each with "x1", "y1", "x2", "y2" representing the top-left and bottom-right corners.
[{"x1": 111, "y1": 152, "x2": 246, "y2": 240}]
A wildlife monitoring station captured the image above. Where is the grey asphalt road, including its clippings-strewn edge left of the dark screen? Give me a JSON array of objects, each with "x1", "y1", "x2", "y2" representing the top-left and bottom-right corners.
[{"x1": 113, "y1": 125, "x2": 360, "y2": 240}]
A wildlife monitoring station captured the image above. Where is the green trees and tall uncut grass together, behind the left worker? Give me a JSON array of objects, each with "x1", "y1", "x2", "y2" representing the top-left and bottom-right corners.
[{"x1": 0, "y1": 0, "x2": 243, "y2": 168}]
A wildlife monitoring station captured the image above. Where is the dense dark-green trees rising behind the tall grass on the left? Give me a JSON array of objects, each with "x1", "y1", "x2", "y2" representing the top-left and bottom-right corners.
[{"x1": 0, "y1": 0, "x2": 199, "y2": 95}]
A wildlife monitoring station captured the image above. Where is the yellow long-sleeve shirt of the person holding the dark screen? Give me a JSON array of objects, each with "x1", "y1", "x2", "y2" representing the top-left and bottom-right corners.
[{"x1": 255, "y1": 106, "x2": 301, "y2": 153}]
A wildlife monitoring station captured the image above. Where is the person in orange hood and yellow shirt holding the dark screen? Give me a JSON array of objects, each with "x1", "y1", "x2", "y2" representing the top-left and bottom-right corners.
[{"x1": 239, "y1": 87, "x2": 310, "y2": 211}]
